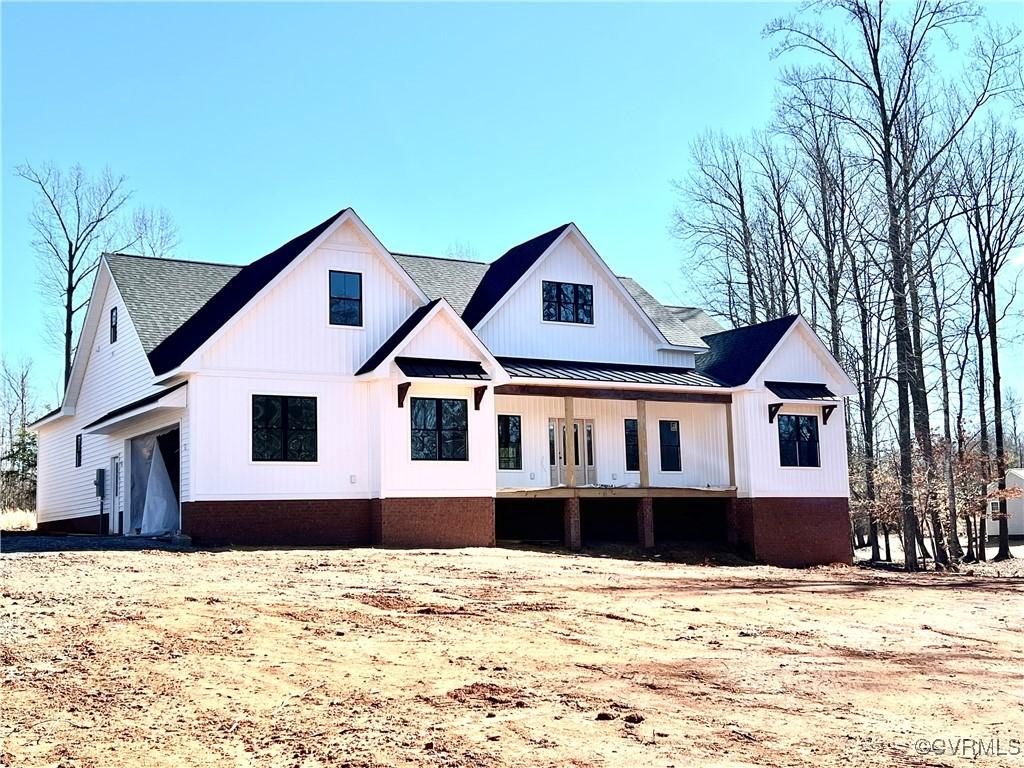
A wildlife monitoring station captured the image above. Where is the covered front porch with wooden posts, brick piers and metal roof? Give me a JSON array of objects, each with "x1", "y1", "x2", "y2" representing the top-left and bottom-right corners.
[{"x1": 495, "y1": 360, "x2": 736, "y2": 549}]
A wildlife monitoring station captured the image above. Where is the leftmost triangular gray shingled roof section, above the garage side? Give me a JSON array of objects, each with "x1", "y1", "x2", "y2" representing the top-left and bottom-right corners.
[{"x1": 103, "y1": 253, "x2": 242, "y2": 354}]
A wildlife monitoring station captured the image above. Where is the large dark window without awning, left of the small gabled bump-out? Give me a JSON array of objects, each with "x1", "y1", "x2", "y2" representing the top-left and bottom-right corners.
[{"x1": 252, "y1": 394, "x2": 316, "y2": 462}]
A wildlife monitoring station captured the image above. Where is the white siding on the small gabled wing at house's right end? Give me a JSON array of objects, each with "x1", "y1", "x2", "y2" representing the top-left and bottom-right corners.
[{"x1": 732, "y1": 327, "x2": 850, "y2": 498}]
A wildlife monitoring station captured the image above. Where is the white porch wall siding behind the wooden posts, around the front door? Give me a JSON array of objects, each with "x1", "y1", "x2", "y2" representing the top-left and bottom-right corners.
[{"x1": 495, "y1": 394, "x2": 729, "y2": 488}]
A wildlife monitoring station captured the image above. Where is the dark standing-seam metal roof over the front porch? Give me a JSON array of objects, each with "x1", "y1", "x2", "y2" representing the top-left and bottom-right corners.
[{"x1": 496, "y1": 357, "x2": 724, "y2": 388}]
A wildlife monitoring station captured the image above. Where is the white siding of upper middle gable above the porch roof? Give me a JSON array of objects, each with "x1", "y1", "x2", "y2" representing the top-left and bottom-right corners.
[{"x1": 475, "y1": 233, "x2": 693, "y2": 368}]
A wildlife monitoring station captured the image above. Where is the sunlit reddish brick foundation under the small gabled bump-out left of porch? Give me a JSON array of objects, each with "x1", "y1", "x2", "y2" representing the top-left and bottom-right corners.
[{"x1": 371, "y1": 497, "x2": 495, "y2": 547}]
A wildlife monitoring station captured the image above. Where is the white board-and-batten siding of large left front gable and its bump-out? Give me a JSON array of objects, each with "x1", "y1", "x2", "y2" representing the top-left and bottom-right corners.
[{"x1": 189, "y1": 224, "x2": 496, "y2": 501}]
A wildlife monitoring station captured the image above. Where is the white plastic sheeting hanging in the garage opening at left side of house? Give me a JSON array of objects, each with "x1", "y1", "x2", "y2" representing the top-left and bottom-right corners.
[{"x1": 127, "y1": 426, "x2": 178, "y2": 536}]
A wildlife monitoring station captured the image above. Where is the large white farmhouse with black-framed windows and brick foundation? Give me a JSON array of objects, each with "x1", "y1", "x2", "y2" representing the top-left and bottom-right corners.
[{"x1": 29, "y1": 209, "x2": 854, "y2": 565}]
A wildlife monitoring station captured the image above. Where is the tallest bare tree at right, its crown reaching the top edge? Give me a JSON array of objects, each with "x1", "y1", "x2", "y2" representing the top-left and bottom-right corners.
[{"x1": 766, "y1": 0, "x2": 1017, "y2": 570}]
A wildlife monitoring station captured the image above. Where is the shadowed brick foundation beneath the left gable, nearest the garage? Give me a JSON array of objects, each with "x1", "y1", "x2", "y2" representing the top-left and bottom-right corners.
[{"x1": 181, "y1": 499, "x2": 372, "y2": 547}]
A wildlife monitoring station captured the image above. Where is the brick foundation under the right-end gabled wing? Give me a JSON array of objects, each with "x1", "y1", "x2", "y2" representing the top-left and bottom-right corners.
[{"x1": 728, "y1": 498, "x2": 853, "y2": 567}]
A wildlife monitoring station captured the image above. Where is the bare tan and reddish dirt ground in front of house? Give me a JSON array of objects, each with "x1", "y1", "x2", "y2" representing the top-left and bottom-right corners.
[{"x1": 0, "y1": 549, "x2": 1024, "y2": 767}]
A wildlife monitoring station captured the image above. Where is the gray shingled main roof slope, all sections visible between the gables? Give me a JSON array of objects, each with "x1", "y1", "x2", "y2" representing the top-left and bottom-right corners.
[{"x1": 104, "y1": 253, "x2": 722, "y2": 362}]
